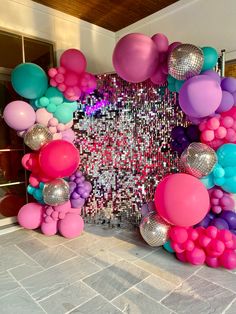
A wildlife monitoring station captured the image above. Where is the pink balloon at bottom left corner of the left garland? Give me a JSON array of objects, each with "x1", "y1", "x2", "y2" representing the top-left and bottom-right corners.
[{"x1": 17, "y1": 203, "x2": 43, "y2": 229}]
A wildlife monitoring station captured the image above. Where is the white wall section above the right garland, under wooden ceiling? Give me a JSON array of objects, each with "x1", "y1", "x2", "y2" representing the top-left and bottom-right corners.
[{"x1": 116, "y1": 0, "x2": 236, "y2": 59}]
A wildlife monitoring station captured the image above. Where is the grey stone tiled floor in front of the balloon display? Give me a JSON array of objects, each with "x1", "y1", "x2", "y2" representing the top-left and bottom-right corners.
[{"x1": 0, "y1": 226, "x2": 236, "y2": 314}]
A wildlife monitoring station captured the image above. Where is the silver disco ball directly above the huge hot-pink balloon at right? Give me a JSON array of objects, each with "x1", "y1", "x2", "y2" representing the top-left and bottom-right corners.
[{"x1": 180, "y1": 143, "x2": 217, "y2": 179}]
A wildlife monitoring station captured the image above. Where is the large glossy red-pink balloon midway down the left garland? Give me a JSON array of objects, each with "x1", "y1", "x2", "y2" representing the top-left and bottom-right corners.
[{"x1": 39, "y1": 140, "x2": 80, "y2": 179}]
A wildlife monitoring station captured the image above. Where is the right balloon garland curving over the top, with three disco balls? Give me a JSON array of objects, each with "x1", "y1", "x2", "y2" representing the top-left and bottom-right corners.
[{"x1": 113, "y1": 33, "x2": 236, "y2": 269}]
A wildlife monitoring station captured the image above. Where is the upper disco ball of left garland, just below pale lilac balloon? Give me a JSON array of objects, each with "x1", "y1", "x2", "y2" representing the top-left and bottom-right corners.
[{"x1": 24, "y1": 124, "x2": 53, "y2": 150}]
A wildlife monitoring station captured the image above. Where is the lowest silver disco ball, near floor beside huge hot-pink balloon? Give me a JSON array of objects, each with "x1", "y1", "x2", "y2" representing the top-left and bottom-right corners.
[{"x1": 139, "y1": 212, "x2": 170, "y2": 246}]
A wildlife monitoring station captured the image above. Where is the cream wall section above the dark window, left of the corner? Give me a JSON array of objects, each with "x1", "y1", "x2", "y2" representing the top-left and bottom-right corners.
[{"x1": 0, "y1": 0, "x2": 115, "y2": 73}]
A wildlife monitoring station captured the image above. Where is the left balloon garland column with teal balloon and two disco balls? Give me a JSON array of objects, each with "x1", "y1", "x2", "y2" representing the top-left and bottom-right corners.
[{"x1": 3, "y1": 49, "x2": 96, "y2": 238}]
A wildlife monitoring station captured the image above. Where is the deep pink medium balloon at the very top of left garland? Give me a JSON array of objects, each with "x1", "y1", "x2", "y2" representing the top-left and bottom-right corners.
[{"x1": 60, "y1": 48, "x2": 87, "y2": 74}]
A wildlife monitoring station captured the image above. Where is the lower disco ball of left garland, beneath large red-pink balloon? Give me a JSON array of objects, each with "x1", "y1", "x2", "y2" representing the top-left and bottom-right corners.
[{"x1": 43, "y1": 179, "x2": 70, "y2": 206}]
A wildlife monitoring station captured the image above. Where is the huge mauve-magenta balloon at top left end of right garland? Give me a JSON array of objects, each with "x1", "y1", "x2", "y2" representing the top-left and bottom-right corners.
[{"x1": 112, "y1": 33, "x2": 158, "y2": 83}]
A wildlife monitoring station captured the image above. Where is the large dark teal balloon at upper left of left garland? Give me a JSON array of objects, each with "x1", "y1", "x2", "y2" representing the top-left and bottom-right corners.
[{"x1": 11, "y1": 63, "x2": 48, "y2": 99}]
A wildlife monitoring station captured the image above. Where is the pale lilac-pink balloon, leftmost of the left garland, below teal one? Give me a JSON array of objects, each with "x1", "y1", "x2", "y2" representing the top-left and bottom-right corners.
[{"x1": 3, "y1": 100, "x2": 36, "y2": 131}]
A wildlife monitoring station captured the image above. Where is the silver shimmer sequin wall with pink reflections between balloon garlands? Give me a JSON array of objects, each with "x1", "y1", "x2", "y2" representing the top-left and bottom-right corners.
[{"x1": 75, "y1": 74, "x2": 184, "y2": 226}]
